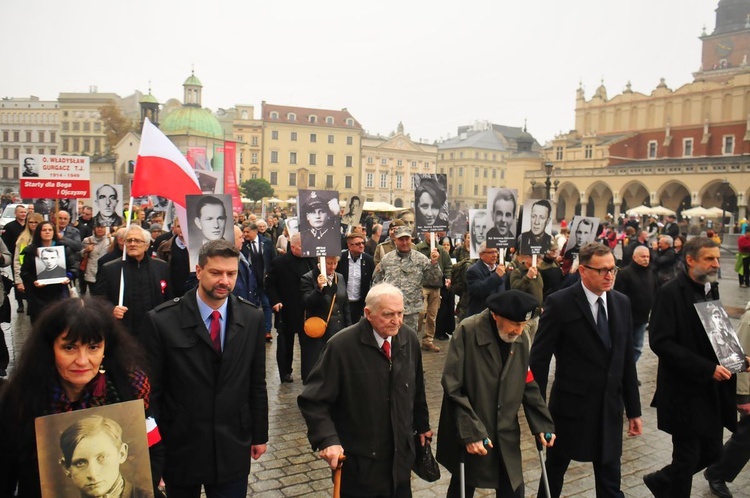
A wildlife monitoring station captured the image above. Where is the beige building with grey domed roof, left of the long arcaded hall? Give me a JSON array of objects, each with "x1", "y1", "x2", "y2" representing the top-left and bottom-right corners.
[{"x1": 437, "y1": 121, "x2": 542, "y2": 209}]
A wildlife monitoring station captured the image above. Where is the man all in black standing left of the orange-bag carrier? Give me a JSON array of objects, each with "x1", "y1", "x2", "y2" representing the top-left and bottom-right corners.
[{"x1": 265, "y1": 233, "x2": 316, "y2": 382}]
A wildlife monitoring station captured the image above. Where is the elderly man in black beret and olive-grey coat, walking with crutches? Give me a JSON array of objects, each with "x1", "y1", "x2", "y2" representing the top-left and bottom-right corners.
[{"x1": 437, "y1": 290, "x2": 555, "y2": 497}]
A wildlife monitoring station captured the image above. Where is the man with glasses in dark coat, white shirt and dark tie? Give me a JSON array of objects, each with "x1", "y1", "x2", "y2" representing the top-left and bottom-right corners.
[{"x1": 529, "y1": 243, "x2": 642, "y2": 498}]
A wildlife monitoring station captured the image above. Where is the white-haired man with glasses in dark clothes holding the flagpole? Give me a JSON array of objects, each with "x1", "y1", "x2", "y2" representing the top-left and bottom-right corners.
[{"x1": 92, "y1": 225, "x2": 172, "y2": 335}]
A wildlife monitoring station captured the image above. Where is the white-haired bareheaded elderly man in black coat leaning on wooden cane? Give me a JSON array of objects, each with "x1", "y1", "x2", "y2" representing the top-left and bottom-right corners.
[{"x1": 297, "y1": 283, "x2": 432, "y2": 497}]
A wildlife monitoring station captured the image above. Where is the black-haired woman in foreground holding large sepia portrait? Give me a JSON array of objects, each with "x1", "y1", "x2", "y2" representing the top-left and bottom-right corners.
[{"x1": 0, "y1": 298, "x2": 161, "y2": 497}]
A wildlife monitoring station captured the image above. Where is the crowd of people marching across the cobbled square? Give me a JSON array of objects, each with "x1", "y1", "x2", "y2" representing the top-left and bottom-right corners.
[{"x1": 0, "y1": 200, "x2": 750, "y2": 498}]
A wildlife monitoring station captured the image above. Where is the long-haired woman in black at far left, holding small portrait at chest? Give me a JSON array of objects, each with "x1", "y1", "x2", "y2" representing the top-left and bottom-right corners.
[{"x1": 21, "y1": 221, "x2": 77, "y2": 323}]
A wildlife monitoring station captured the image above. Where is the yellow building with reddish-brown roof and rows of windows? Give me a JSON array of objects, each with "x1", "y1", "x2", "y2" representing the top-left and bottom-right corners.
[{"x1": 261, "y1": 101, "x2": 362, "y2": 200}]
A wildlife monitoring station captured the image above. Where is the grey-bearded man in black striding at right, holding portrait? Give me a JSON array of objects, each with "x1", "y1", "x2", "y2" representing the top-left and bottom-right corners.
[{"x1": 643, "y1": 237, "x2": 750, "y2": 498}]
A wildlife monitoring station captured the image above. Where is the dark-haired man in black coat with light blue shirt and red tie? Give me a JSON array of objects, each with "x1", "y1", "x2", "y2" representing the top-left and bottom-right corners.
[{"x1": 140, "y1": 240, "x2": 268, "y2": 498}]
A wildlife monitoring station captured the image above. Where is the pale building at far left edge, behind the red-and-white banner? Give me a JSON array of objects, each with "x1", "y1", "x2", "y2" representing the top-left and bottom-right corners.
[{"x1": 0, "y1": 96, "x2": 60, "y2": 193}]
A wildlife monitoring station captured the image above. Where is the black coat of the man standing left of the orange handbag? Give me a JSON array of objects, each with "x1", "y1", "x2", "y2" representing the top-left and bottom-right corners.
[{"x1": 265, "y1": 251, "x2": 315, "y2": 334}]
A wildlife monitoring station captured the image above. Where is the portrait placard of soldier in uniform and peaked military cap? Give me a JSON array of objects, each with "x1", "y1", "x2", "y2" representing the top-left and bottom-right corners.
[{"x1": 299, "y1": 190, "x2": 341, "y2": 257}]
